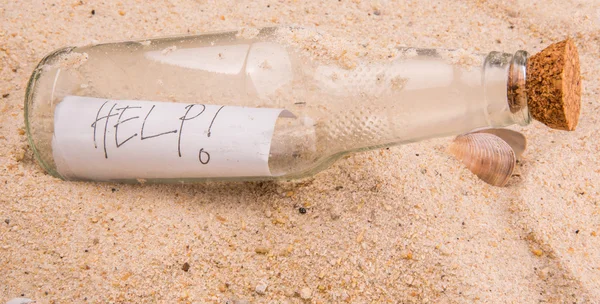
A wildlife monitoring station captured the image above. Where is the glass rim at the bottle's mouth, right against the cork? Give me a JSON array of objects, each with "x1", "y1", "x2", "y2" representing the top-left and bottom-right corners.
[{"x1": 506, "y1": 50, "x2": 531, "y2": 126}]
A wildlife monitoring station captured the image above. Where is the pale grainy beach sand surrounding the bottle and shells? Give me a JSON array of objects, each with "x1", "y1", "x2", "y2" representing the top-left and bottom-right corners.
[{"x1": 0, "y1": 0, "x2": 600, "y2": 303}]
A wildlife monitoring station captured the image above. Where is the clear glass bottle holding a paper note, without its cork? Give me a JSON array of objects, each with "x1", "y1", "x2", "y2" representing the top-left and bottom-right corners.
[{"x1": 25, "y1": 27, "x2": 530, "y2": 182}]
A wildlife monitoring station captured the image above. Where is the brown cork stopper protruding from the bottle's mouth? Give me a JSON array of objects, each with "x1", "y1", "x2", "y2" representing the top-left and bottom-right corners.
[{"x1": 526, "y1": 38, "x2": 581, "y2": 131}]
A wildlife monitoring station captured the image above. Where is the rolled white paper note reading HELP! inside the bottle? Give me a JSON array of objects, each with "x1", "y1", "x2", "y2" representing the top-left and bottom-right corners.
[{"x1": 52, "y1": 96, "x2": 287, "y2": 180}]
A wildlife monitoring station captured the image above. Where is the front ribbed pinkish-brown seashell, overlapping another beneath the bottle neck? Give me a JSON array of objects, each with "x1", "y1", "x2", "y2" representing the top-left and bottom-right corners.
[{"x1": 449, "y1": 132, "x2": 517, "y2": 187}]
